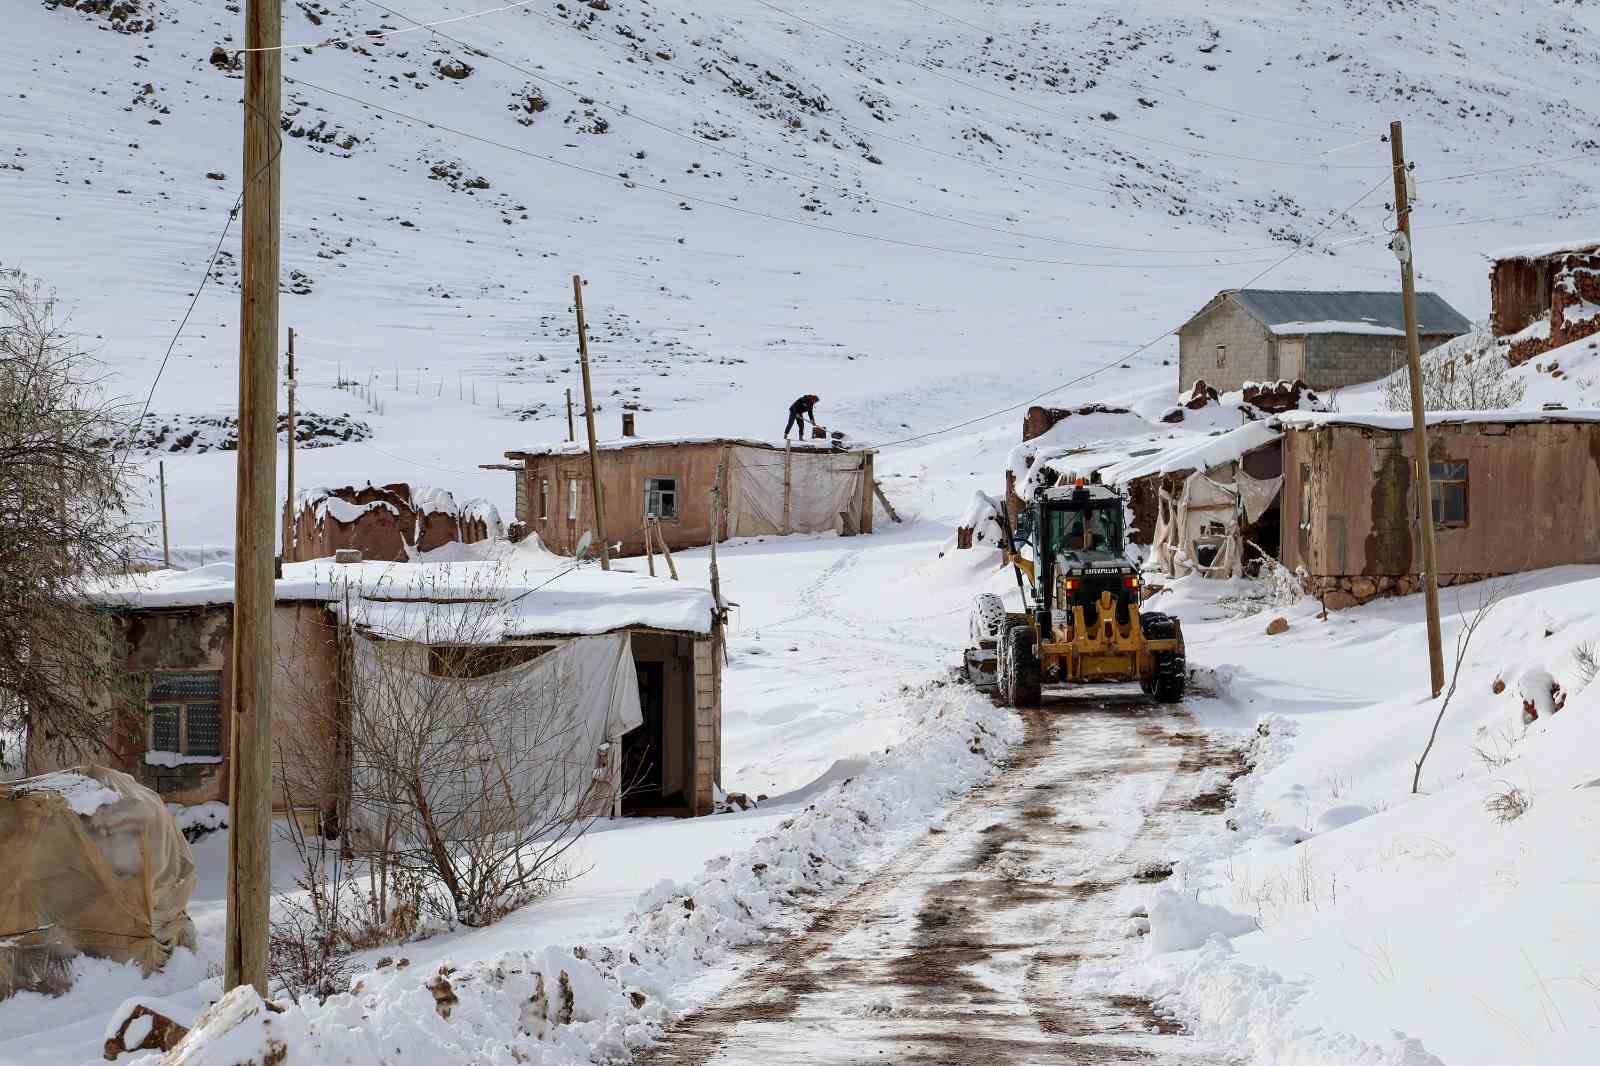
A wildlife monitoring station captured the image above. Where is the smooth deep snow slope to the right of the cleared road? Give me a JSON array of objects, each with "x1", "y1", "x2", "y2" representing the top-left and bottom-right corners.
[{"x1": 1123, "y1": 567, "x2": 1600, "y2": 1066}]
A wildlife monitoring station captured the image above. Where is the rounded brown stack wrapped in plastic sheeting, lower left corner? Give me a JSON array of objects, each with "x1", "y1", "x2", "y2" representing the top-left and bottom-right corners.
[{"x1": 0, "y1": 767, "x2": 195, "y2": 997}]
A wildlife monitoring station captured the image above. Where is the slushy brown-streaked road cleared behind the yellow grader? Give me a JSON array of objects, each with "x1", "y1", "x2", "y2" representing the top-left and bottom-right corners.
[{"x1": 637, "y1": 690, "x2": 1240, "y2": 1066}]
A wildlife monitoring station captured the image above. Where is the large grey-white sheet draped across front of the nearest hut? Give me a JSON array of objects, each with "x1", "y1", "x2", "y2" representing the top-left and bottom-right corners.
[{"x1": 350, "y1": 632, "x2": 643, "y2": 842}]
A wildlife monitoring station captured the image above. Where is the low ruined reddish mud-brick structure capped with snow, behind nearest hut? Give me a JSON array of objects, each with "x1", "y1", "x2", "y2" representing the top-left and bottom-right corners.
[{"x1": 283, "y1": 482, "x2": 506, "y2": 562}]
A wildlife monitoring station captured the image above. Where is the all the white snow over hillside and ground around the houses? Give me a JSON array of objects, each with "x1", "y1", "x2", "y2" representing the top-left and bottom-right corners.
[{"x1": 0, "y1": 0, "x2": 1600, "y2": 1066}]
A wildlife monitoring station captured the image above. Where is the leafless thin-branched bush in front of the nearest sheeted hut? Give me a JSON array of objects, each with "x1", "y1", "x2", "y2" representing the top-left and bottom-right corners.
[{"x1": 277, "y1": 568, "x2": 604, "y2": 943}]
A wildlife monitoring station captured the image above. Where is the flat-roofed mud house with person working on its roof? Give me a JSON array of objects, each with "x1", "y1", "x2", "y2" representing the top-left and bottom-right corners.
[{"x1": 485, "y1": 437, "x2": 882, "y2": 555}]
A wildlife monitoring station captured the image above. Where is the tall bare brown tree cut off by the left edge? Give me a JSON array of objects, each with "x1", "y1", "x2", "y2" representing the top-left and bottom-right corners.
[{"x1": 0, "y1": 267, "x2": 142, "y2": 757}]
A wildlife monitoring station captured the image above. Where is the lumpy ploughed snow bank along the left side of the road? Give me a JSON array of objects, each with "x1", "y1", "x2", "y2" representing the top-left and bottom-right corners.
[{"x1": 152, "y1": 683, "x2": 1021, "y2": 1066}]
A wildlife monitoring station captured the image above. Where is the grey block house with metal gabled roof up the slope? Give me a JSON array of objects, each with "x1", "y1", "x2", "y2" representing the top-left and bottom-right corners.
[{"x1": 1178, "y1": 288, "x2": 1470, "y2": 392}]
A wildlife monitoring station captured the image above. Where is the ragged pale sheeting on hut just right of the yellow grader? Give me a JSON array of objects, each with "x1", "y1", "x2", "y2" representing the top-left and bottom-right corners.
[{"x1": 1152, "y1": 463, "x2": 1283, "y2": 578}]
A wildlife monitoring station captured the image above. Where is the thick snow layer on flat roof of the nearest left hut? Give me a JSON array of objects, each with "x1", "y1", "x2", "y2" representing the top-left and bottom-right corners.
[{"x1": 90, "y1": 538, "x2": 712, "y2": 633}]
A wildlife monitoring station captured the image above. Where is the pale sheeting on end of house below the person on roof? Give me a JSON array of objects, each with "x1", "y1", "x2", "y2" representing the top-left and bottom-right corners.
[{"x1": 728, "y1": 448, "x2": 861, "y2": 536}]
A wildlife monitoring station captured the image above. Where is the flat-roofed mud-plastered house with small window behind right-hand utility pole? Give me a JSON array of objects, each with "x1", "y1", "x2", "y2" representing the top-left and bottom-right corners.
[{"x1": 1278, "y1": 411, "x2": 1600, "y2": 608}]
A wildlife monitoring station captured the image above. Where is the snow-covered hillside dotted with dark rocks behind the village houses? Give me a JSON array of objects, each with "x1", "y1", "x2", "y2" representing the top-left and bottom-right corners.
[{"x1": 0, "y1": 0, "x2": 1600, "y2": 544}]
